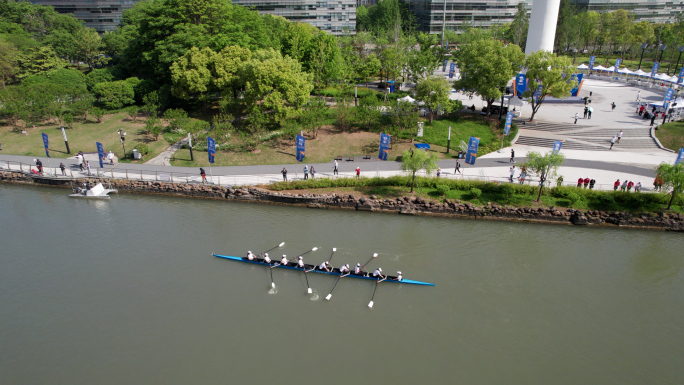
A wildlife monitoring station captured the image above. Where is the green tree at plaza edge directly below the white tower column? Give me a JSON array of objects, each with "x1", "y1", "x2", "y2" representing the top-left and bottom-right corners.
[{"x1": 524, "y1": 51, "x2": 577, "y2": 122}]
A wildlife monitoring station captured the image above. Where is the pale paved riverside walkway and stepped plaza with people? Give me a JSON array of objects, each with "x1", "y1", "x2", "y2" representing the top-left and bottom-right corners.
[{"x1": 0, "y1": 79, "x2": 676, "y2": 191}]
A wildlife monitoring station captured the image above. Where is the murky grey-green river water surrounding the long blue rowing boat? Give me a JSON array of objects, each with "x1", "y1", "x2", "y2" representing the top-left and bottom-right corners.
[{"x1": 0, "y1": 185, "x2": 684, "y2": 384}]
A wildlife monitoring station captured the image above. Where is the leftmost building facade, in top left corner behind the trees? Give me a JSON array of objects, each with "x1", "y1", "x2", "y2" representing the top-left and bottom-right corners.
[{"x1": 29, "y1": 0, "x2": 138, "y2": 33}]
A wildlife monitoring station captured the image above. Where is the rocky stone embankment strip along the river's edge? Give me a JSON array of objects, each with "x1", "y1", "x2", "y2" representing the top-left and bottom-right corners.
[{"x1": 0, "y1": 171, "x2": 684, "y2": 231}]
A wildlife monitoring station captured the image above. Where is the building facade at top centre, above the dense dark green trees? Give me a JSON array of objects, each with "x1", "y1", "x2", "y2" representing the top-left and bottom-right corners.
[{"x1": 233, "y1": 0, "x2": 356, "y2": 35}]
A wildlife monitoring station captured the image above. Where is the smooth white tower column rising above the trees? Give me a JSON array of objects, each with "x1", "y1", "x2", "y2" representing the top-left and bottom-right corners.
[{"x1": 525, "y1": 0, "x2": 560, "y2": 55}]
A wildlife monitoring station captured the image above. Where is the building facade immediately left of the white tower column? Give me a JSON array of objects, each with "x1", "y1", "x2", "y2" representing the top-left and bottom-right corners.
[{"x1": 409, "y1": 0, "x2": 528, "y2": 33}]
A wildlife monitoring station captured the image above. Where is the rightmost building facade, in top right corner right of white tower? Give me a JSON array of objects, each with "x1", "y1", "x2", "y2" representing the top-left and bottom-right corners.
[{"x1": 571, "y1": 0, "x2": 684, "y2": 23}]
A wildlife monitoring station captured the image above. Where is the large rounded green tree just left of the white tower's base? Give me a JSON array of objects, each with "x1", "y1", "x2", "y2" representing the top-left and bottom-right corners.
[{"x1": 456, "y1": 39, "x2": 524, "y2": 116}]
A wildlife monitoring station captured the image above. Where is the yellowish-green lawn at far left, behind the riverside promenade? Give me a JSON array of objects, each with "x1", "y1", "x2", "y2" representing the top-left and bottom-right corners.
[{"x1": 0, "y1": 112, "x2": 169, "y2": 162}]
